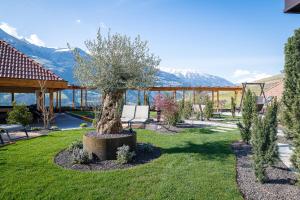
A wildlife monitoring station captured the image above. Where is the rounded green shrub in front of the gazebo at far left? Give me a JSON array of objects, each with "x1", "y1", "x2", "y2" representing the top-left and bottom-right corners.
[{"x1": 7, "y1": 102, "x2": 33, "y2": 126}]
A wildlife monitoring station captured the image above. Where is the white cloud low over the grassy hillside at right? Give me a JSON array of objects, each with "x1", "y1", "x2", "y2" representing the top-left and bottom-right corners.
[{"x1": 232, "y1": 69, "x2": 271, "y2": 83}]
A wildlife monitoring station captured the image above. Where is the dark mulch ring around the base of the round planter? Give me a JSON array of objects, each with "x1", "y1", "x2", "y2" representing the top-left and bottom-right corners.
[{"x1": 54, "y1": 144, "x2": 161, "y2": 171}]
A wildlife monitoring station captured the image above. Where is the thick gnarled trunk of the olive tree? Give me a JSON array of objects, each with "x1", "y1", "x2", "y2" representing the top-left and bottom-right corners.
[{"x1": 97, "y1": 91, "x2": 123, "y2": 135}]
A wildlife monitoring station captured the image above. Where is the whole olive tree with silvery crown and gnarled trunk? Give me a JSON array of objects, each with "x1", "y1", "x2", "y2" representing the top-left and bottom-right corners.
[{"x1": 74, "y1": 29, "x2": 160, "y2": 134}]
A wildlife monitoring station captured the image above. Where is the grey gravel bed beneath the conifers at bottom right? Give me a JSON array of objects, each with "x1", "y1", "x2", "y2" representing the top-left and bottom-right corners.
[{"x1": 232, "y1": 143, "x2": 300, "y2": 200}]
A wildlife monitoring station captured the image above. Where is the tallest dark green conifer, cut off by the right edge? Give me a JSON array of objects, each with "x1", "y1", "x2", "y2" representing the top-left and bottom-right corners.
[{"x1": 283, "y1": 29, "x2": 300, "y2": 169}]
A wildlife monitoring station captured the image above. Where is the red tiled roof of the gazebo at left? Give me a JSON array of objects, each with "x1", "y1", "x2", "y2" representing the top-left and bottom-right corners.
[{"x1": 0, "y1": 40, "x2": 63, "y2": 81}]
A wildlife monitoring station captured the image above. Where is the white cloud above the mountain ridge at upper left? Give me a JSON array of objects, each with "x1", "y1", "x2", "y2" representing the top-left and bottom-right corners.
[{"x1": 0, "y1": 22, "x2": 45, "y2": 46}]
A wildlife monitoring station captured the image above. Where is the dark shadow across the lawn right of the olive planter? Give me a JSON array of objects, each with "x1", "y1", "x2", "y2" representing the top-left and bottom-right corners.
[{"x1": 162, "y1": 141, "x2": 234, "y2": 160}]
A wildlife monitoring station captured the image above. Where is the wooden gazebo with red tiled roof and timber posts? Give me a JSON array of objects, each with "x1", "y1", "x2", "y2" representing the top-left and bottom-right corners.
[{"x1": 0, "y1": 40, "x2": 70, "y2": 112}]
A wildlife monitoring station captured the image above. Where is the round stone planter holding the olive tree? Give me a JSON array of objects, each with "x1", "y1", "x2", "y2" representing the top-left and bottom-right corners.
[{"x1": 82, "y1": 130, "x2": 136, "y2": 160}]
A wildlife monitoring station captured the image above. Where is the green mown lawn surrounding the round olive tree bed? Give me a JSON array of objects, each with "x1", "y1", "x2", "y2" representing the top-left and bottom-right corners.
[{"x1": 0, "y1": 129, "x2": 242, "y2": 200}]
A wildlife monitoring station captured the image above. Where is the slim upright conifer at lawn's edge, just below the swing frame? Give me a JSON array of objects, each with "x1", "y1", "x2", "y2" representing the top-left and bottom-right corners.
[{"x1": 237, "y1": 89, "x2": 256, "y2": 144}]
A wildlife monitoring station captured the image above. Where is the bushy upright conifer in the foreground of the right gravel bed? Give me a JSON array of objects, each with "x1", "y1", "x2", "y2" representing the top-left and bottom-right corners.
[{"x1": 251, "y1": 101, "x2": 278, "y2": 183}]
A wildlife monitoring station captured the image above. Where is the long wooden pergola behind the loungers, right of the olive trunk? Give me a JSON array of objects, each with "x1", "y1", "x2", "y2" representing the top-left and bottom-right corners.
[{"x1": 125, "y1": 86, "x2": 243, "y2": 110}]
